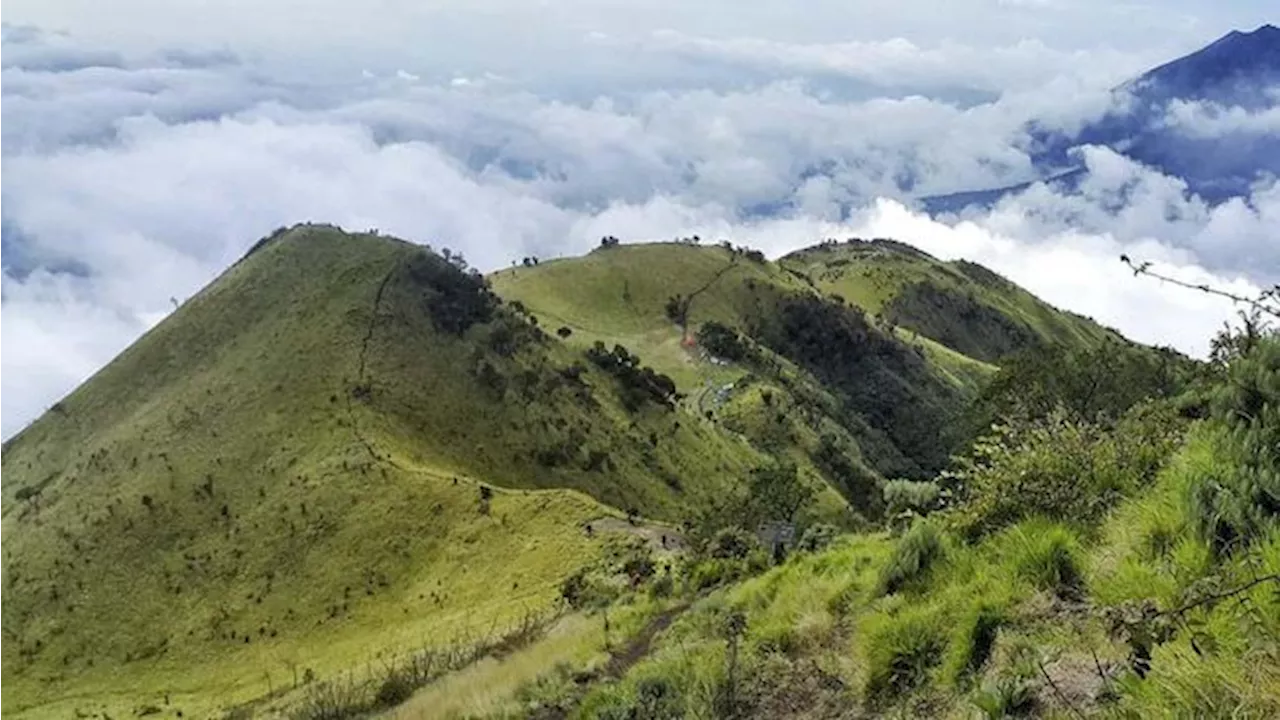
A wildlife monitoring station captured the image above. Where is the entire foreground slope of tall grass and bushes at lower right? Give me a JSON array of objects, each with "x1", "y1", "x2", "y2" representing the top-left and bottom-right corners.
[{"x1": 448, "y1": 325, "x2": 1239, "y2": 719}]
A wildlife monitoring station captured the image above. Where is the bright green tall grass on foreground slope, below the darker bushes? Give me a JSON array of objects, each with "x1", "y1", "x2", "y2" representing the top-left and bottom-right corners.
[{"x1": 575, "y1": 412, "x2": 1280, "y2": 719}]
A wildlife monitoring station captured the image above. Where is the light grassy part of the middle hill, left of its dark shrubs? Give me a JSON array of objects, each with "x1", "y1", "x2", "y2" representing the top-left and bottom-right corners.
[{"x1": 490, "y1": 243, "x2": 870, "y2": 516}]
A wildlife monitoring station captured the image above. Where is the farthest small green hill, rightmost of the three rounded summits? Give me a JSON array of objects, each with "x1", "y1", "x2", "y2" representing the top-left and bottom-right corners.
[{"x1": 780, "y1": 240, "x2": 1120, "y2": 363}]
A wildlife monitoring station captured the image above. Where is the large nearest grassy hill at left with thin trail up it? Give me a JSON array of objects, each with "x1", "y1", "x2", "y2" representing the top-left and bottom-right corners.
[{"x1": 0, "y1": 228, "x2": 753, "y2": 717}]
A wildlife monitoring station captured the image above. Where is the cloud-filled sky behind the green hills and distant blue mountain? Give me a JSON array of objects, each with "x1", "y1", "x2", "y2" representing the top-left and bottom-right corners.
[{"x1": 0, "y1": 0, "x2": 1280, "y2": 437}]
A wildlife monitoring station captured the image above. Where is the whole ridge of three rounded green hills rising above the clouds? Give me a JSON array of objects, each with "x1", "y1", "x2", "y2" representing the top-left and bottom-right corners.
[{"x1": 0, "y1": 225, "x2": 1141, "y2": 717}]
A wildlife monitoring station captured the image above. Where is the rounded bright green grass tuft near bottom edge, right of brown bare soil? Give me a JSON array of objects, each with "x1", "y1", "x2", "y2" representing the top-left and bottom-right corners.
[{"x1": 865, "y1": 610, "x2": 945, "y2": 706}]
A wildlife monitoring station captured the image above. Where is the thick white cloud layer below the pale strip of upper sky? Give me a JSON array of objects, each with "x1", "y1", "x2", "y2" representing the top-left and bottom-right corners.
[{"x1": 0, "y1": 20, "x2": 1280, "y2": 437}]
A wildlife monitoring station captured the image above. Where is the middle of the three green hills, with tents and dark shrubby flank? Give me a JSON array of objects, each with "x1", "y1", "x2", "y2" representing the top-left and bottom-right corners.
[{"x1": 492, "y1": 243, "x2": 1049, "y2": 486}]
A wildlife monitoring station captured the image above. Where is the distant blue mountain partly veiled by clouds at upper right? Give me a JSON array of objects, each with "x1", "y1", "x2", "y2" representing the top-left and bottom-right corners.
[{"x1": 922, "y1": 24, "x2": 1280, "y2": 214}]
